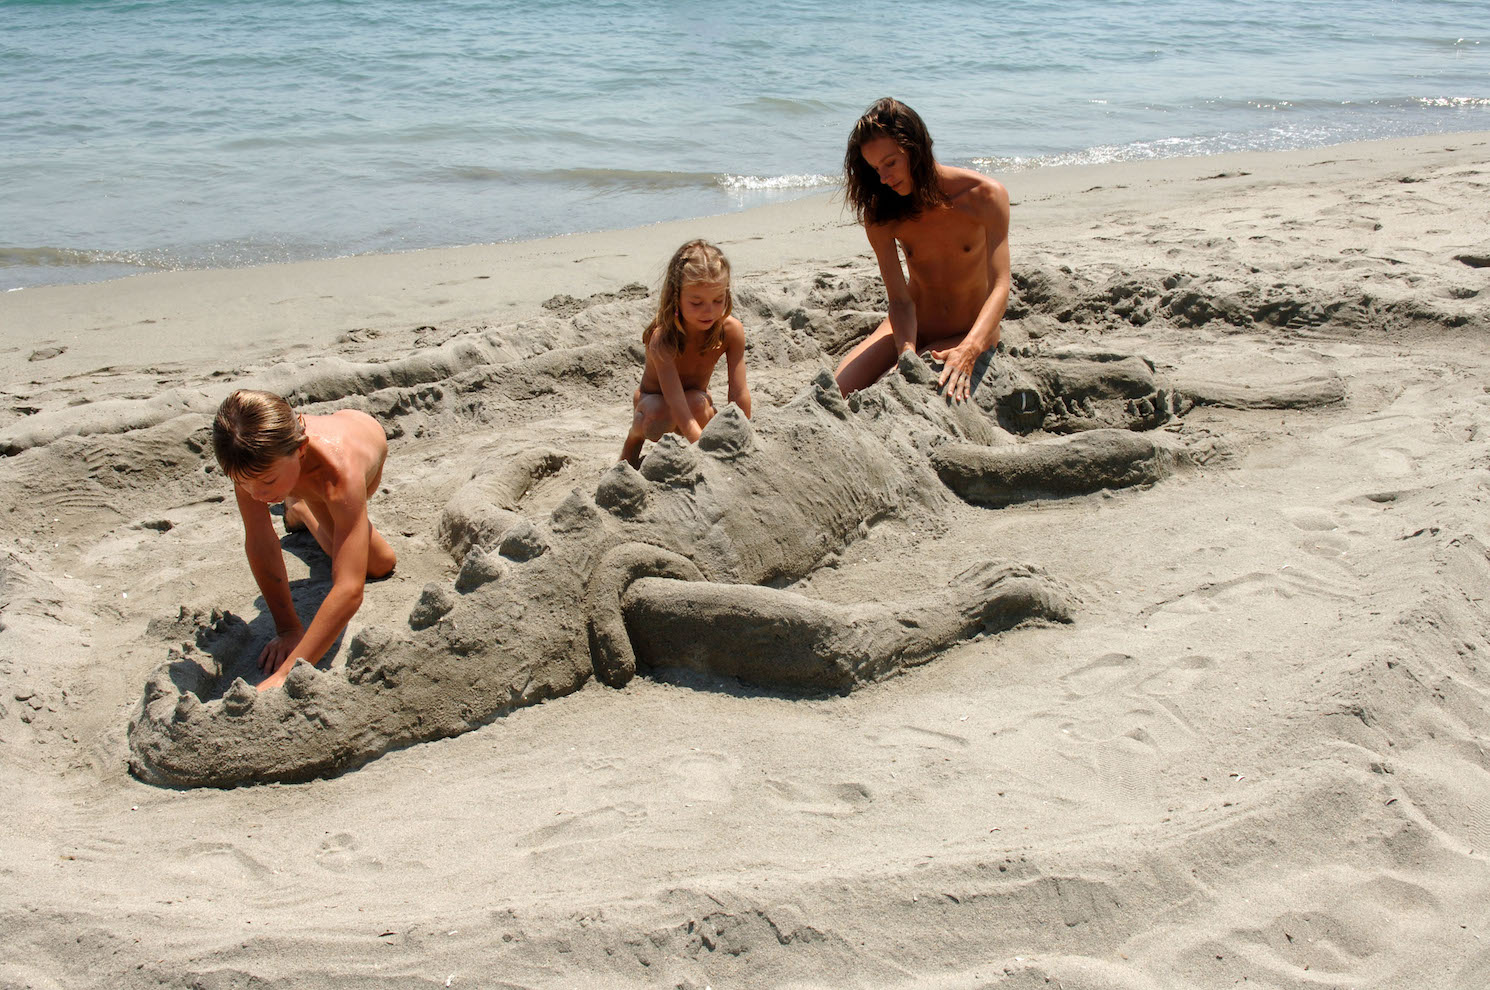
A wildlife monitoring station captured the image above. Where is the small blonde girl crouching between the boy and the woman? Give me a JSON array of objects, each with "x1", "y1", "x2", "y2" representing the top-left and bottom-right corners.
[{"x1": 621, "y1": 240, "x2": 749, "y2": 467}]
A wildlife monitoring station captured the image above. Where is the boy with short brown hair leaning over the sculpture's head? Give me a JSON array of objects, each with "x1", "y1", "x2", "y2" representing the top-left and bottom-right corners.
[{"x1": 212, "y1": 389, "x2": 396, "y2": 690}]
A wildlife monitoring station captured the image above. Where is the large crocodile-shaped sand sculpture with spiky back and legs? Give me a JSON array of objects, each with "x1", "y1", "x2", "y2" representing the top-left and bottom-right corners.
[{"x1": 130, "y1": 310, "x2": 1340, "y2": 787}]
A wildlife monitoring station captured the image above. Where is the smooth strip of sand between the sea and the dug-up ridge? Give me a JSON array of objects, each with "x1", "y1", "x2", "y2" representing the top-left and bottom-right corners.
[{"x1": 0, "y1": 131, "x2": 1490, "y2": 387}]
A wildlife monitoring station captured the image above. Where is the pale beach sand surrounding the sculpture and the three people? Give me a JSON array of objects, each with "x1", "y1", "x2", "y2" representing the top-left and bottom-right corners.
[{"x1": 0, "y1": 134, "x2": 1490, "y2": 990}]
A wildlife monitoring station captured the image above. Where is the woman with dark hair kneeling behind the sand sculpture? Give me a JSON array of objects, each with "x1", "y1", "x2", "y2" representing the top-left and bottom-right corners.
[{"x1": 836, "y1": 98, "x2": 1009, "y2": 401}]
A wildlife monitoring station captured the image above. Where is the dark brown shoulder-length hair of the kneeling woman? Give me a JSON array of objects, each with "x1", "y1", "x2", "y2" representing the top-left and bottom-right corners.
[{"x1": 843, "y1": 97, "x2": 948, "y2": 225}]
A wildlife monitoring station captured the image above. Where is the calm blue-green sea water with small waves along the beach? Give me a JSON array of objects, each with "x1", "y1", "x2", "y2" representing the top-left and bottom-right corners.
[{"x1": 0, "y1": 0, "x2": 1490, "y2": 289}]
